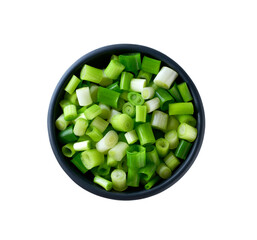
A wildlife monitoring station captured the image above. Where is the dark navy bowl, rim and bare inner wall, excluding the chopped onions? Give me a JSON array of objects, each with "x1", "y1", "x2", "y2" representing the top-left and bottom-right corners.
[{"x1": 47, "y1": 44, "x2": 205, "y2": 200}]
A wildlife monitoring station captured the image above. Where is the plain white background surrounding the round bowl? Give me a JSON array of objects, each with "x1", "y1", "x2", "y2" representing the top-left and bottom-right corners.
[{"x1": 0, "y1": 0, "x2": 257, "y2": 240}]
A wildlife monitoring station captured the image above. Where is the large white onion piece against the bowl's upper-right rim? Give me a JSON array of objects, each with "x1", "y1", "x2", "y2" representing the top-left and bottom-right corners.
[{"x1": 153, "y1": 67, "x2": 178, "y2": 89}]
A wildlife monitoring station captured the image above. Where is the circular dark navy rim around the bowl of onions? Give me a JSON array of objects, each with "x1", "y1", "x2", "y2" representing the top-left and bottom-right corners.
[{"x1": 47, "y1": 44, "x2": 205, "y2": 200}]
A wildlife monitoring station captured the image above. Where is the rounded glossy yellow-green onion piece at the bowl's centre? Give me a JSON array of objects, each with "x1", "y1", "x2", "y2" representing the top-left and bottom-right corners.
[{"x1": 111, "y1": 113, "x2": 134, "y2": 132}]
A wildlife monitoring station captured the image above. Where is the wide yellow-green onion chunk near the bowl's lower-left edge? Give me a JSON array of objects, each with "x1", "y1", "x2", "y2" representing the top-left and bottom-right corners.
[{"x1": 81, "y1": 149, "x2": 104, "y2": 170}]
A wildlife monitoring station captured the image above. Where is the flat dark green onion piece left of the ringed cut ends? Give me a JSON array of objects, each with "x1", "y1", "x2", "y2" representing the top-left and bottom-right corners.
[{"x1": 97, "y1": 87, "x2": 120, "y2": 108}]
